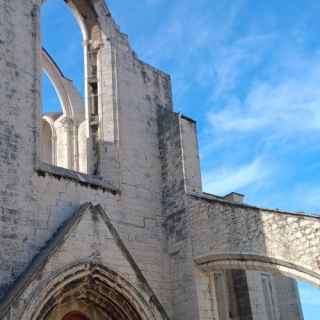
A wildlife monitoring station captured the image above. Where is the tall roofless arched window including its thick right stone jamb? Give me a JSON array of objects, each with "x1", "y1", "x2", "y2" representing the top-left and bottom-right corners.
[{"x1": 38, "y1": 0, "x2": 110, "y2": 175}]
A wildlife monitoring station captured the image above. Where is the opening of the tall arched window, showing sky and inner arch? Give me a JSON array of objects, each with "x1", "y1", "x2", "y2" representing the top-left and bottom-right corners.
[{"x1": 40, "y1": 1, "x2": 87, "y2": 173}]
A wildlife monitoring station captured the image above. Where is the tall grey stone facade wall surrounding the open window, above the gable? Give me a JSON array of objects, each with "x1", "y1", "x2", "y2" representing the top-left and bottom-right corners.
[{"x1": 0, "y1": 0, "x2": 171, "y2": 316}]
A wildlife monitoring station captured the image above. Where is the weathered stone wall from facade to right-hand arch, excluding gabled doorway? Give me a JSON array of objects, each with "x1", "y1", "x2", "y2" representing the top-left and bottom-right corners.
[{"x1": 0, "y1": 0, "x2": 320, "y2": 320}]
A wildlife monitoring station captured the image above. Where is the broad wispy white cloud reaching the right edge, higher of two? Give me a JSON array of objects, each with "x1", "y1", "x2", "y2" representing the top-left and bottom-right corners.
[{"x1": 208, "y1": 52, "x2": 320, "y2": 136}]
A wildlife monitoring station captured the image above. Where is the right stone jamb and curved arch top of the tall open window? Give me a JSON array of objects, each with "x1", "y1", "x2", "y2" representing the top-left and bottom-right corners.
[{"x1": 37, "y1": 0, "x2": 119, "y2": 175}]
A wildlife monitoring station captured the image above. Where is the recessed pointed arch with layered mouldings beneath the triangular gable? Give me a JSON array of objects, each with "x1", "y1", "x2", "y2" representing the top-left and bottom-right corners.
[{"x1": 21, "y1": 262, "x2": 161, "y2": 320}]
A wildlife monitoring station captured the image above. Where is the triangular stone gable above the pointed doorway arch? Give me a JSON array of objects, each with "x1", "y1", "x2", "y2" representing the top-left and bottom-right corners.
[{"x1": 0, "y1": 203, "x2": 168, "y2": 319}]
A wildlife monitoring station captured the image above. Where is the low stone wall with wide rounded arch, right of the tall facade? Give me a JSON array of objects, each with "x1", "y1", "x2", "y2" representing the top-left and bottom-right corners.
[{"x1": 165, "y1": 194, "x2": 319, "y2": 320}]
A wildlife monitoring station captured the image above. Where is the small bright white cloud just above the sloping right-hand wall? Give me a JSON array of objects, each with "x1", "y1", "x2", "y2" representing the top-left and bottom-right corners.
[{"x1": 204, "y1": 157, "x2": 272, "y2": 195}]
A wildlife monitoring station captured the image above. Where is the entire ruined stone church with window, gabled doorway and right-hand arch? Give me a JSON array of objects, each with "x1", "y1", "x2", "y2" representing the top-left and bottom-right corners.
[{"x1": 0, "y1": 0, "x2": 320, "y2": 320}]
